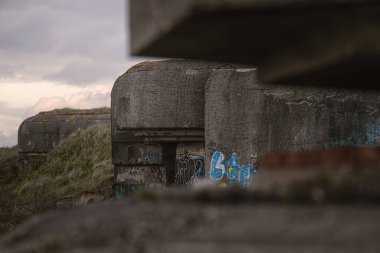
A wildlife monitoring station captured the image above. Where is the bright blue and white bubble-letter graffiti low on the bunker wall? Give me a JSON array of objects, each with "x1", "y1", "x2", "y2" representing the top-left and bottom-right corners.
[{"x1": 210, "y1": 151, "x2": 257, "y2": 187}]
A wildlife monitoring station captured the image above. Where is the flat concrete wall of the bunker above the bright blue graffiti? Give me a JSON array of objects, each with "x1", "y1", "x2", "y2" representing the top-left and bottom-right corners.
[{"x1": 205, "y1": 69, "x2": 380, "y2": 165}]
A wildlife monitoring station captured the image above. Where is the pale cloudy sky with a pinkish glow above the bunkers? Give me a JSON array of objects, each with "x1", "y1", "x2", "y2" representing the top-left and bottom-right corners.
[{"x1": 0, "y1": 0, "x2": 146, "y2": 146}]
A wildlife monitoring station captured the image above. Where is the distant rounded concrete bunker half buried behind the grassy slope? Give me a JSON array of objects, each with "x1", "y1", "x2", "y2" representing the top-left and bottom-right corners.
[{"x1": 18, "y1": 109, "x2": 111, "y2": 166}]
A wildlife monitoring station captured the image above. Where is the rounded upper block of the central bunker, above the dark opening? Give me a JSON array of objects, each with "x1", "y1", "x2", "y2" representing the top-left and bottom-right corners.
[{"x1": 111, "y1": 60, "x2": 229, "y2": 136}]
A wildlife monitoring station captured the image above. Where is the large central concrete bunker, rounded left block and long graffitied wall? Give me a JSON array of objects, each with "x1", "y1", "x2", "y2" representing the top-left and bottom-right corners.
[{"x1": 111, "y1": 60, "x2": 380, "y2": 188}]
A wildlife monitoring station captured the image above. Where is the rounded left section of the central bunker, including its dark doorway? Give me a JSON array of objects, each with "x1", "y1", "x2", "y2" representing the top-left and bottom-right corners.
[{"x1": 111, "y1": 60, "x2": 229, "y2": 187}]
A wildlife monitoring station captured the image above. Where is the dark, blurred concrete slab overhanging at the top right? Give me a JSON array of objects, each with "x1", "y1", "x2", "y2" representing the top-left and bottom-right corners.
[{"x1": 130, "y1": 0, "x2": 380, "y2": 89}]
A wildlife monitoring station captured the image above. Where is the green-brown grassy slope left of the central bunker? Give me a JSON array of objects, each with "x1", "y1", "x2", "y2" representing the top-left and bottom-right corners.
[{"x1": 0, "y1": 126, "x2": 113, "y2": 234}]
